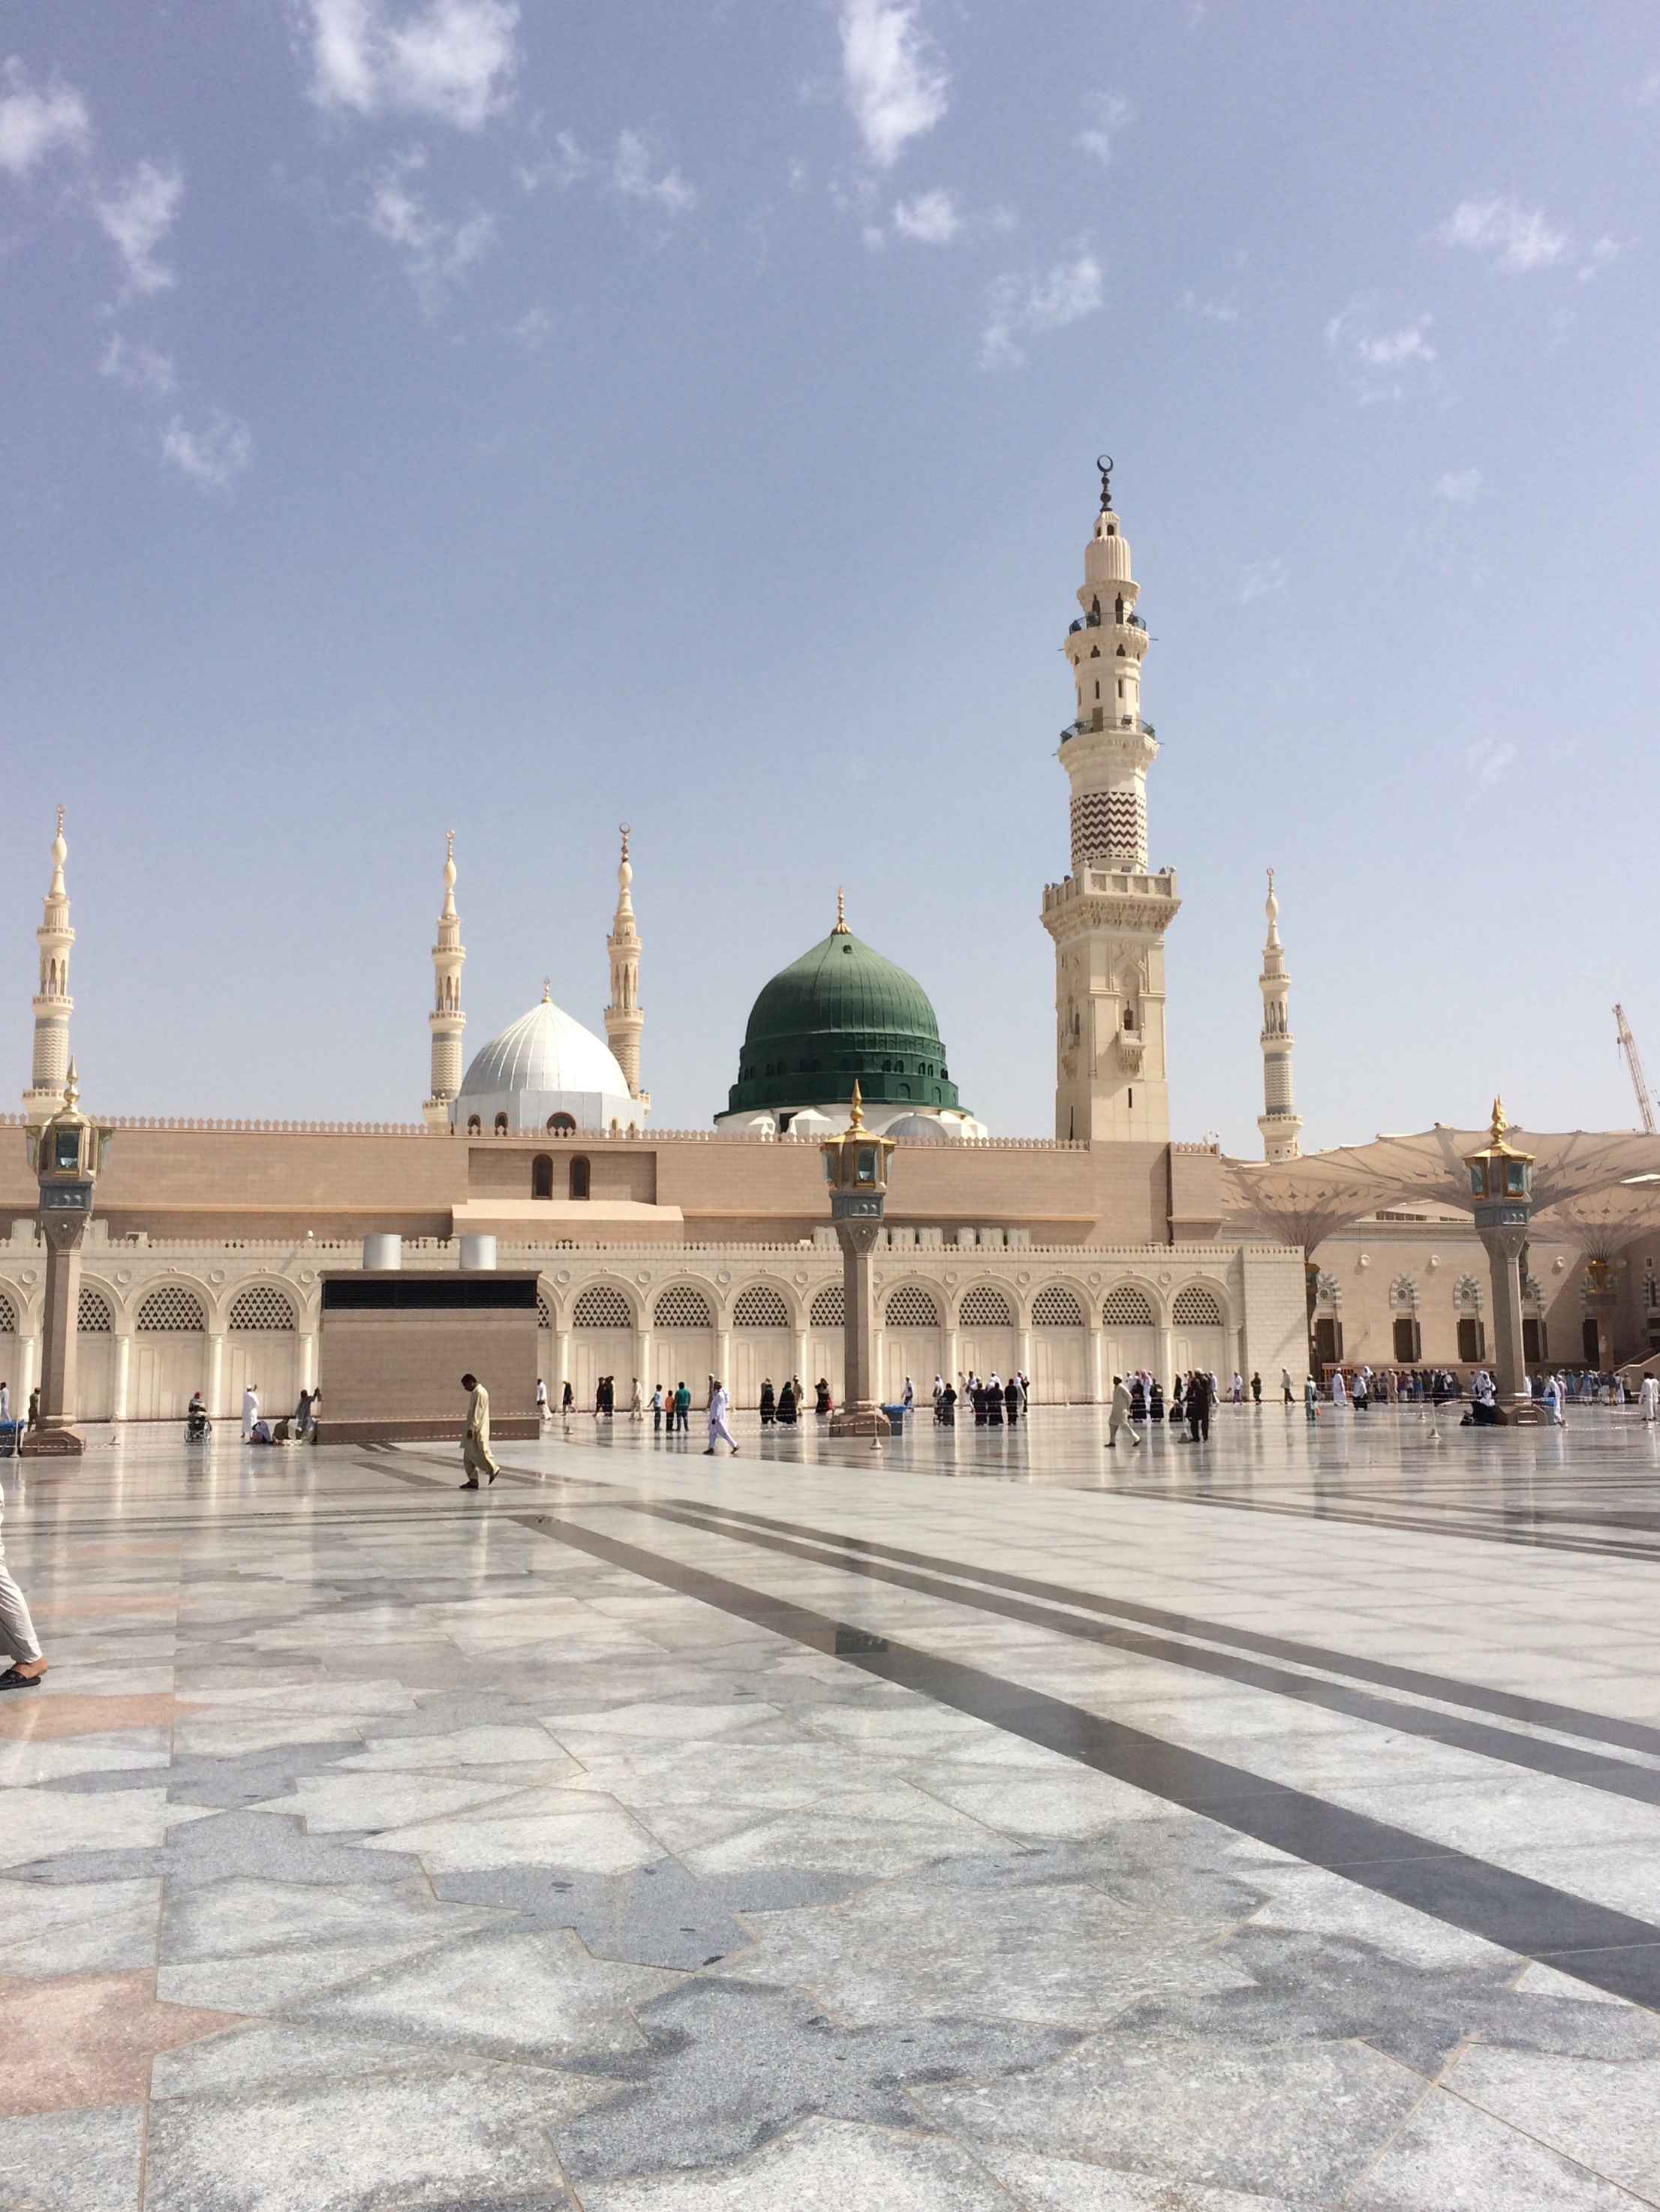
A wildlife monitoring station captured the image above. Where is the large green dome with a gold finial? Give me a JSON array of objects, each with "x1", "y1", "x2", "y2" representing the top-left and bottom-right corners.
[{"x1": 728, "y1": 929, "x2": 958, "y2": 1113}]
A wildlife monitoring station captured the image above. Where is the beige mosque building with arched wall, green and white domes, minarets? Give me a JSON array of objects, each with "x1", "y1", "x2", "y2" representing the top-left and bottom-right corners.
[{"x1": 0, "y1": 473, "x2": 1407, "y2": 1420}]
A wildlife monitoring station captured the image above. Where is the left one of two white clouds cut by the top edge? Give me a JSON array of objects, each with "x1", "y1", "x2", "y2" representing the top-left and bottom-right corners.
[{"x1": 303, "y1": 0, "x2": 518, "y2": 131}]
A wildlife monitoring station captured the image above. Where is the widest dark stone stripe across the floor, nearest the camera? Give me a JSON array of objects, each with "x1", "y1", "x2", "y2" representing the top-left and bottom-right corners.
[{"x1": 526, "y1": 1513, "x2": 1660, "y2": 2009}]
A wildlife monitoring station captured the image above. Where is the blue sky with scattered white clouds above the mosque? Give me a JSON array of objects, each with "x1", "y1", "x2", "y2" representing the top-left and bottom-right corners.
[{"x1": 0, "y1": 13, "x2": 1660, "y2": 1153}]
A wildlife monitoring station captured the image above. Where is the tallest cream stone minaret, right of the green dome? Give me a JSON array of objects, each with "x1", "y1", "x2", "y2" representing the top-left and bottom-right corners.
[{"x1": 1042, "y1": 458, "x2": 1182, "y2": 1144}]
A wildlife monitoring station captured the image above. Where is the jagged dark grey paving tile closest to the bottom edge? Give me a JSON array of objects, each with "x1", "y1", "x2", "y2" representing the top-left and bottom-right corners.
[{"x1": 555, "y1": 1979, "x2": 1073, "y2": 2194}]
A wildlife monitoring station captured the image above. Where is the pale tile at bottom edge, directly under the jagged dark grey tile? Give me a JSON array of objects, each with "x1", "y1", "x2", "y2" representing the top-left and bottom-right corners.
[{"x1": 582, "y1": 2119, "x2": 1012, "y2": 2212}]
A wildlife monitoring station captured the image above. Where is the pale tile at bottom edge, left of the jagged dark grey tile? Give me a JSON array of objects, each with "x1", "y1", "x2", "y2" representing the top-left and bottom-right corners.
[{"x1": 144, "y1": 2062, "x2": 611, "y2": 2212}]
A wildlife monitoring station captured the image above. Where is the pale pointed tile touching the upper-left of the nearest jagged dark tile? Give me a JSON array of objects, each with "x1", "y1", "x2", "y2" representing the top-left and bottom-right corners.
[{"x1": 305, "y1": 1929, "x2": 679, "y2": 2063}]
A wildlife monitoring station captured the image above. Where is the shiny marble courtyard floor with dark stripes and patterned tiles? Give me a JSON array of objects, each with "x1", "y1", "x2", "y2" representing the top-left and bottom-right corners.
[{"x1": 0, "y1": 1405, "x2": 1660, "y2": 2212}]
